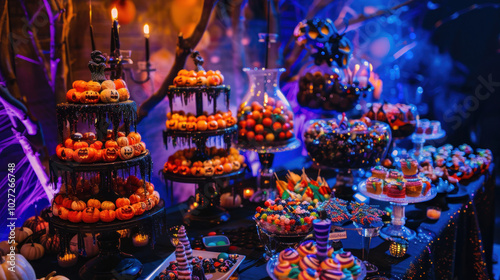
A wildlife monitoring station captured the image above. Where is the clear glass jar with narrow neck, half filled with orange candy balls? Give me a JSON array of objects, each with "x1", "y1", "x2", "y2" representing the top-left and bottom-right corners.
[{"x1": 238, "y1": 68, "x2": 295, "y2": 149}]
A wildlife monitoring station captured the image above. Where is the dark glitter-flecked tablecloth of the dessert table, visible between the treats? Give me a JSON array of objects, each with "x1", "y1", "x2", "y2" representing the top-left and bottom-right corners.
[{"x1": 32, "y1": 158, "x2": 494, "y2": 279}]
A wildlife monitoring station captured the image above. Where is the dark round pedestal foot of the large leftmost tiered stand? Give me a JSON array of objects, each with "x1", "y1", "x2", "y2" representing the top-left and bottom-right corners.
[{"x1": 79, "y1": 232, "x2": 143, "y2": 280}]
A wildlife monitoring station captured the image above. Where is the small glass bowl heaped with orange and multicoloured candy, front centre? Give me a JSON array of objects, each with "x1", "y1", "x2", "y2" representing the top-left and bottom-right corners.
[{"x1": 254, "y1": 198, "x2": 318, "y2": 257}]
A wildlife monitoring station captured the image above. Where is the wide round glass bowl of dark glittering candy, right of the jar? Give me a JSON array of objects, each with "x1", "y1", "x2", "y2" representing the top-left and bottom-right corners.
[{"x1": 304, "y1": 115, "x2": 392, "y2": 170}]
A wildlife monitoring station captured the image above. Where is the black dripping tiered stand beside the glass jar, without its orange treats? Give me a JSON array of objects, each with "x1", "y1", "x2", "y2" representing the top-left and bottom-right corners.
[{"x1": 162, "y1": 86, "x2": 246, "y2": 224}]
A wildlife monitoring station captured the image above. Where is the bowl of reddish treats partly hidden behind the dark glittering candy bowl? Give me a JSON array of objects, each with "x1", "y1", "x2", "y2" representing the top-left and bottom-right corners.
[{"x1": 364, "y1": 103, "x2": 418, "y2": 138}]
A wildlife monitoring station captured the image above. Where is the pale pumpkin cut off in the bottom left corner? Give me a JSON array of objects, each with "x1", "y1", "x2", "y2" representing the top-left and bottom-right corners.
[{"x1": 0, "y1": 254, "x2": 36, "y2": 280}]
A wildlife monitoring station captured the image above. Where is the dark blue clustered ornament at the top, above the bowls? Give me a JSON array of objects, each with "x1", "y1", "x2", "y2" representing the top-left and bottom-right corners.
[{"x1": 294, "y1": 18, "x2": 352, "y2": 68}]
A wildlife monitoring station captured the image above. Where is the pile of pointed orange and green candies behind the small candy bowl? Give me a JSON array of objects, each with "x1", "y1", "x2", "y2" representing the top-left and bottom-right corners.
[{"x1": 275, "y1": 169, "x2": 332, "y2": 203}]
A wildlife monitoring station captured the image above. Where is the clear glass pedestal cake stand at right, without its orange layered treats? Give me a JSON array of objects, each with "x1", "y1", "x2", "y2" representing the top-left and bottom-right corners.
[{"x1": 359, "y1": 182, "x2": 437, "y2": 240}]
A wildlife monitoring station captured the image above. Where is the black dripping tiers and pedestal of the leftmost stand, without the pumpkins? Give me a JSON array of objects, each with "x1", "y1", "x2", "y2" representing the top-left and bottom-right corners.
[{"x1": 49, "y1": 101, "x2": 166, "y2": 279}]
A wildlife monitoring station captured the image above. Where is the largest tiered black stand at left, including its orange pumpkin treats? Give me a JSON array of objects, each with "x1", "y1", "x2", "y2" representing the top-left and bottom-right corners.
[{"x1": 49, "y1": 51, "x2": 165, "y2": 279}]
